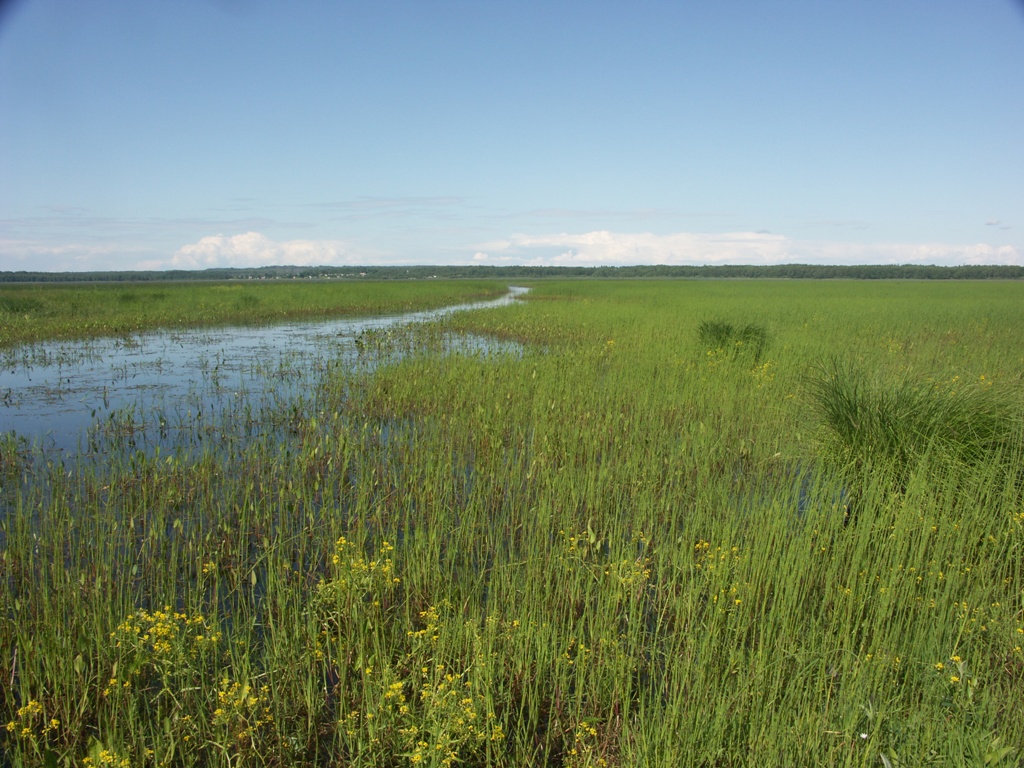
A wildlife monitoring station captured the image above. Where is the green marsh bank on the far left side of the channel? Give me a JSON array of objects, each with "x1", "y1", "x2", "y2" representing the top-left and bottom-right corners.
[{"x1": 0, "y1": 281, "x2": 506, "y2": 347}]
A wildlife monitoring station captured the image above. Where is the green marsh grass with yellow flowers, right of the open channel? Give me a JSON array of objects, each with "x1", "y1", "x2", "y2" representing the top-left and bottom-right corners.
[{"x1": 0, "y1": 282, "x2": 1024, "y2": 768}]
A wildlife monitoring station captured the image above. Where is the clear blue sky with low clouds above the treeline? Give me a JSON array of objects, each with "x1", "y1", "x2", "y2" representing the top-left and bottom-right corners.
[{"x1": 0, "y1": 0, "x2": 1024, "y2": 271}]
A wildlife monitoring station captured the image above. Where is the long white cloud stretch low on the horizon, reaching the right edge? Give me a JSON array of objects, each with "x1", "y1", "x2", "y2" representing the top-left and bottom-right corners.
[{"x1": 474, "y1": 230, "x2": 1024, "y2": 266}]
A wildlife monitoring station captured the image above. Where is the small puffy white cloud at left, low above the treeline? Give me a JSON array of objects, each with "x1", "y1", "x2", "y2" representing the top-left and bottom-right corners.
[{"x1": 164, "y1": 232, "x2": 357, "y2": 269}]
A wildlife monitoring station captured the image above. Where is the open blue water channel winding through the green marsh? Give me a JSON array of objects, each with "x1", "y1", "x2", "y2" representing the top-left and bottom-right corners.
[{"x1": 0, "y1": 288, "x2": 526, "y2": 452}]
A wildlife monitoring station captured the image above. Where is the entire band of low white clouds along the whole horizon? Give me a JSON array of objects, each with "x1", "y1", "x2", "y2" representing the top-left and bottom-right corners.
[{"x1": 0, "y1": 229, "x2": 1024, "y2": 271}]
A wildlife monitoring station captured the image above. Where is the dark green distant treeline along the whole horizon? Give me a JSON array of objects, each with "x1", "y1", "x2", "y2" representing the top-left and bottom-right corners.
[{"x1": 0, "y1": 264, "x2": 1024, "y2": 283}]
